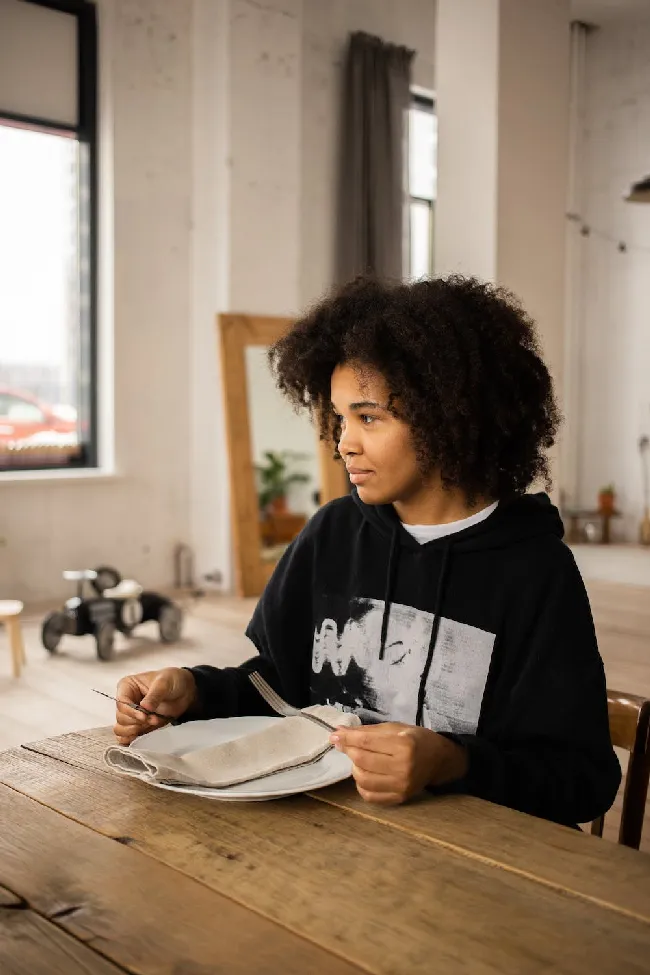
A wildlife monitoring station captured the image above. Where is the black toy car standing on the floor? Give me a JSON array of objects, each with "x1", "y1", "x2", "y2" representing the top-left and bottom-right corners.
[{"x1": 41, "y1": 565, "x2": 183, "y2": 660}]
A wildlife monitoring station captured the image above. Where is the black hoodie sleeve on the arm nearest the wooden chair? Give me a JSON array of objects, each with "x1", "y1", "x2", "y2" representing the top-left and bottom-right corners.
[{"x1": 438, "y1": 546, "x2": 621, "y2": 825}]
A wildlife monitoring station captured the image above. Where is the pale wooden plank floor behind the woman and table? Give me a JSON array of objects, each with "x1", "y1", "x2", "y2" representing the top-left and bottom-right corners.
[{"x1": 0, "y1": 582, "x2": 650, "y2": 852}]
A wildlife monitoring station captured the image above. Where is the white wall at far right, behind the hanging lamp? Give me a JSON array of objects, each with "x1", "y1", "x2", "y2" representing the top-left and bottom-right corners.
[{"x1": 572, "y1": 10, "x2": 650, "y2": 540}]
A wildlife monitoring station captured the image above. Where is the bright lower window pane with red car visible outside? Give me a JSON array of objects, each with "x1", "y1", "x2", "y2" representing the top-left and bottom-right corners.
[{"x1": 0, "y1": 124, "x2": 88, "y2": 467}]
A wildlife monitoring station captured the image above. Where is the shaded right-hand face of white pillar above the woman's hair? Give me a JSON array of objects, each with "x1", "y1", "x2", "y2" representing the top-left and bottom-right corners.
[{"x1": 497, "y1": 0, "x2": 570, "y2": 410}]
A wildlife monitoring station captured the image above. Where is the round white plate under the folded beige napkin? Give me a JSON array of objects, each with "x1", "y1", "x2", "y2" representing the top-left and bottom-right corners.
[{"x1": 132, "y1": 716, "x2": 352, "y2": 802}]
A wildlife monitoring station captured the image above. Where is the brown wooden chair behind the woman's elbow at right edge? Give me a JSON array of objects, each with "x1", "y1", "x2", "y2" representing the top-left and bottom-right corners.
[{"x1": 591, "y1": 690, "x2": 650, "y2": 850}]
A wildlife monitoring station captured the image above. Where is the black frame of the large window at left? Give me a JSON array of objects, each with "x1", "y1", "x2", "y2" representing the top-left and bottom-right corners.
[{"x1": 0, "y1": 0, "x2": 99, "y2": 475}]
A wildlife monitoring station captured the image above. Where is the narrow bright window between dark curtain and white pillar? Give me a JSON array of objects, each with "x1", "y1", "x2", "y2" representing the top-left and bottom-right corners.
[{"x1": 409, "y1": 94, "x2": 438, "y2": 279}]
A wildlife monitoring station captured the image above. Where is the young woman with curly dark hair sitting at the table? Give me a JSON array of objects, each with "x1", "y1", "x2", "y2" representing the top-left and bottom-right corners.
[{"x1": 115, "y1": 277, "x2": 620, "y2": 825}]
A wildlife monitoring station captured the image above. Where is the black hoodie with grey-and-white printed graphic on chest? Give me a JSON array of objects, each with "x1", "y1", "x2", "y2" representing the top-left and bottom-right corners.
[{"x1": 187, "y1": 492, "x2": 621, "y2": 825}]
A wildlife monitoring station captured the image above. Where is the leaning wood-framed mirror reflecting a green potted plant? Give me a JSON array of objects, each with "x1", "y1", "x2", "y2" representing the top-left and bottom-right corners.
[{"x1": 219, "y1": 315, "x2": 348, "y2": 596}]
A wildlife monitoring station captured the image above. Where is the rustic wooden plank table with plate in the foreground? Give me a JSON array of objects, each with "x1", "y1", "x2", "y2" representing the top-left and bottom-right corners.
[{"x1": 0, "y1": 730, "x2": 650, "y2": 975}]
